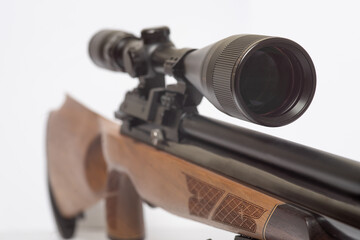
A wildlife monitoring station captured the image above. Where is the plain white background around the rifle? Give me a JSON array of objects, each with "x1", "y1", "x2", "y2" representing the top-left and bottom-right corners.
[{"x1": 0, "y1": 0, "x2": 360, "y2": 239}]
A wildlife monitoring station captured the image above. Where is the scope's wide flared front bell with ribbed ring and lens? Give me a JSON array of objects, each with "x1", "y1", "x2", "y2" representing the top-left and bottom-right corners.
[{"x1": 184, "y1": 35, "x2": 316, "y2": 127}]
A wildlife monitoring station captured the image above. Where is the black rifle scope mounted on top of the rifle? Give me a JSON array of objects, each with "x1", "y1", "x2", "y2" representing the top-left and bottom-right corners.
[{"x1": 89, "y1": 27, "x2": 316, "y2": 127}]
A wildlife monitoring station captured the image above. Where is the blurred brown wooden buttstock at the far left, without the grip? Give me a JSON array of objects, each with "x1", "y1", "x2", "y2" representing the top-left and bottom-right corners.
[{"x1": 46, "y1": 97, "x2": 107, "y2": 217}]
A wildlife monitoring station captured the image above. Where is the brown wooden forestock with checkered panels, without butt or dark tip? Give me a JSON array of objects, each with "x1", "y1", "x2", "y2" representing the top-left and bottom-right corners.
[{"x1": 102, "y1": 119, "x2": 281, "y2": 239}]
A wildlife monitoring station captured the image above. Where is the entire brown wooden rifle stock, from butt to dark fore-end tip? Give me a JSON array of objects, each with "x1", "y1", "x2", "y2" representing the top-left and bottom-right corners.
[{"x1": 47, "y1": 97, "x2": 346, "y2": 240}]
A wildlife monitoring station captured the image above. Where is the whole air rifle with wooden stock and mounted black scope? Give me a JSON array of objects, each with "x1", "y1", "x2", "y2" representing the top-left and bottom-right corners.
[{"x1": 47, "y1": 27, "x2": 360, "y2": 240}]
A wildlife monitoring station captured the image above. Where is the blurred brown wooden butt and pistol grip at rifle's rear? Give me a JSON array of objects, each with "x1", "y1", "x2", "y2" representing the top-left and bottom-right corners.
[{"x1": 46, "y1": 97, "x2": 145, "y2": 240}]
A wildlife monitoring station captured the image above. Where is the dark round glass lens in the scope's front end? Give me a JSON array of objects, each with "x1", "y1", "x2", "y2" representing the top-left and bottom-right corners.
[{"x1": 238, "y1": 47, "x2": 294, "y2": 116}]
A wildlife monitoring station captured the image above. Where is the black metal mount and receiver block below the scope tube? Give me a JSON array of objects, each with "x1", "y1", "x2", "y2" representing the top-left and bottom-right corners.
[{"x1": 115, "y1": 82, "x2": 202, "y2": 142}]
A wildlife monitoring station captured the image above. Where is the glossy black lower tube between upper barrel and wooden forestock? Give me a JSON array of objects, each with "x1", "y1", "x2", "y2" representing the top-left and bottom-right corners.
[{"x1": 121, "y1": 119, "x2": 360, "y2": 228}]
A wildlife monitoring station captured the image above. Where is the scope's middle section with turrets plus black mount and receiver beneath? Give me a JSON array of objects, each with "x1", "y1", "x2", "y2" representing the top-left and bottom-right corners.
[{"x1": 115, "y1": 27, "x2": 202, "y2": 141}]
